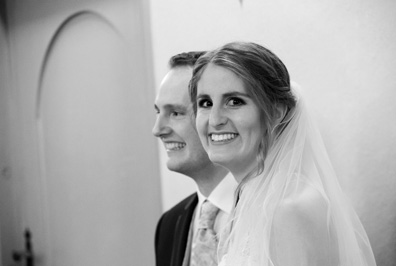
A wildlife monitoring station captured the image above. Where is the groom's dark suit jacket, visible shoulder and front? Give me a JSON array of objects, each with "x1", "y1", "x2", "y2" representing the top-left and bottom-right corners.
[{"x1": 155, "y1": 193, "x2": 198, "y2": 266}]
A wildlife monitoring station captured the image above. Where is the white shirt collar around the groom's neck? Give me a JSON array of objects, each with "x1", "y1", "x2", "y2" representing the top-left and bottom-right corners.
[{"x1": 197, "y1": 173, "x2": 238, "y2": 214}]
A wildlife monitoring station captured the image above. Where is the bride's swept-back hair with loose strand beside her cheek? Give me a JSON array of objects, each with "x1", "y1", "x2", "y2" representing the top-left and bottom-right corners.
[{"x1": 190, "y1": 42, "x2": 296, "y2": 182}]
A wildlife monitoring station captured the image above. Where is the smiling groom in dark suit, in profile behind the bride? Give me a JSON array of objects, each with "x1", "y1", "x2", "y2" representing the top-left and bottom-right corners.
[{"x1": 153, "y1": 52, "x2": 237, "y2": 266}]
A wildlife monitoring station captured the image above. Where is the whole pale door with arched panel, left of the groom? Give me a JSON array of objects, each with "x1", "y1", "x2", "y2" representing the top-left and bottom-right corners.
[{"x1": 2, "y1": 0, "x2": 160, "y2": 266}]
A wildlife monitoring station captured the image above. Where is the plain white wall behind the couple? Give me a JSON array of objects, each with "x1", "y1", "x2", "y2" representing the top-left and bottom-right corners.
[{"x1": 150, "y1": 0, "x2": 396, "y2": 265}]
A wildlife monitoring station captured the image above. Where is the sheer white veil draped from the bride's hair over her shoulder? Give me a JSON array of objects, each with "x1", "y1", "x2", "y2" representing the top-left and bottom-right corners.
[{"x1": 218, "y1": 84, "x2": 376, "y2": 266}]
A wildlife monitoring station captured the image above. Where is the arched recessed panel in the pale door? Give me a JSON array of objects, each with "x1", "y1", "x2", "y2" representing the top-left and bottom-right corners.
[{"x1": 38, "y1": 13, "x2": 139, "y2": 265}]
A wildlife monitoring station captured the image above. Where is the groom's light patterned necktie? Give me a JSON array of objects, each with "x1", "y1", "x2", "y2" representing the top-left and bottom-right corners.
[{"x1": 190, "y1": 200, "x2": 219, "y2": 266}]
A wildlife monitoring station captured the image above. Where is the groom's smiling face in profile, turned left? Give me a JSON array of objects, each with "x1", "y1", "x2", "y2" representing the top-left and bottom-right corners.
[{"x1": 153, "y1": 66, "x2": 212, "y2": 176}]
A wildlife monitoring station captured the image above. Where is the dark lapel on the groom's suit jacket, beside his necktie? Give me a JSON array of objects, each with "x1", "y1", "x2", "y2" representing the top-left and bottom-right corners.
[{"x1": 171, "y1": 194, "x2": 198, "y2": 266}]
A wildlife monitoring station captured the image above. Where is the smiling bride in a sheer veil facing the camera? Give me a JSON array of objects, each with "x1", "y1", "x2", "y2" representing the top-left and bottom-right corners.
[{"x1": 190, "y1": 42, "x2": 376, "y2": 266}]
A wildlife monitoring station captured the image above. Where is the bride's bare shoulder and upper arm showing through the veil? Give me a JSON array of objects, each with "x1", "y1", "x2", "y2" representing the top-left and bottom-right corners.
[{"x1": 271, "y1": 185, "x2": 336, "y2": 265}]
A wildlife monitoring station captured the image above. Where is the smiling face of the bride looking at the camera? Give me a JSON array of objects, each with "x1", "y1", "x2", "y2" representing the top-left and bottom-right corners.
[{"x1": 196, "y1": 64, "x2": 263, "y2": 182}]
